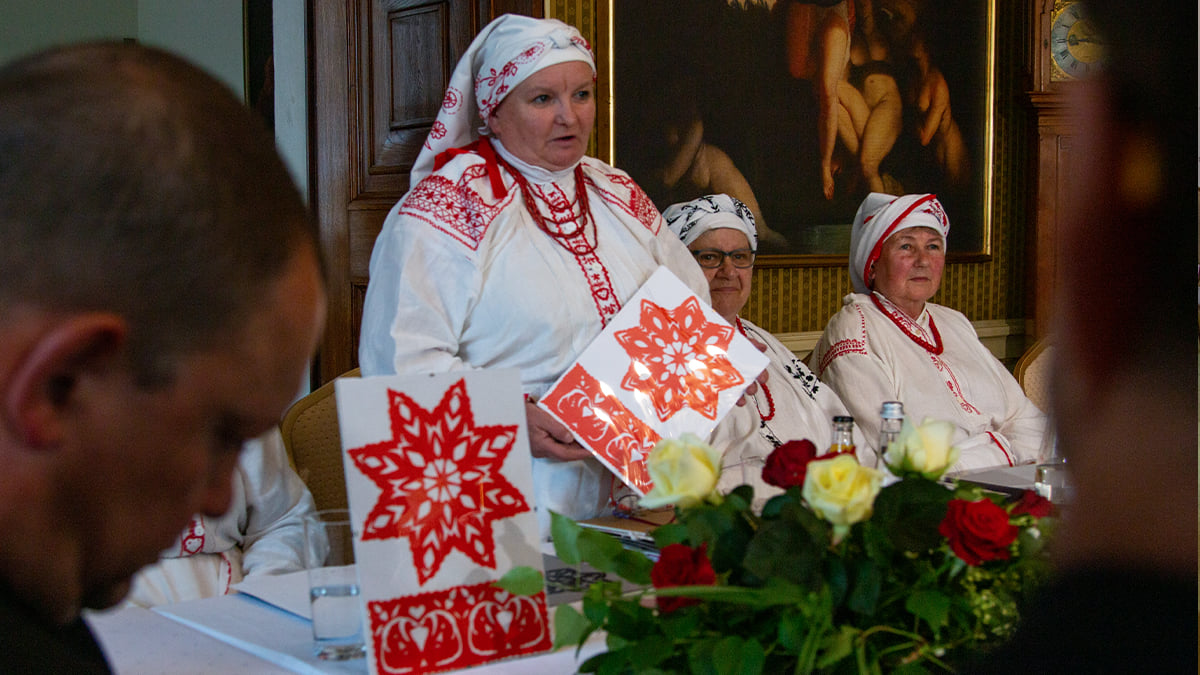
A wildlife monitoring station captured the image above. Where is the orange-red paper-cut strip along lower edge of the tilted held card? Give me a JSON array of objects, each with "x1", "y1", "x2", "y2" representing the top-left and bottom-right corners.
[{"x1": 541, "y1": 364, "x2": 660, "y2": 494}]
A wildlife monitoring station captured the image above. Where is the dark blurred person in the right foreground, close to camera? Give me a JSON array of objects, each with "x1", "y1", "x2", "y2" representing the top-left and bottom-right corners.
[{"x1": 964, "y1": 0, "x2": 1198, "y2": 673}]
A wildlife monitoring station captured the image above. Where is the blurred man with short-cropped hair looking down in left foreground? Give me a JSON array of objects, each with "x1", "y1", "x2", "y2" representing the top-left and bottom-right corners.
[{"x1": 0, "y1": 43, "x2": 325, "y2": 673}]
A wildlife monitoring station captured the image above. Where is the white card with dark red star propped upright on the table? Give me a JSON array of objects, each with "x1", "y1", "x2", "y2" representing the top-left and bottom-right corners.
[{"x1": 336, "y1": 369, "x2": 552, "y2": 674}]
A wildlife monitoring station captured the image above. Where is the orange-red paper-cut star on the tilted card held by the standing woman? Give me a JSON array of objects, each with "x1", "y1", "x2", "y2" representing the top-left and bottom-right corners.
[{"x1": 614, "y1": 297, "x2": 745, "y2": 422}]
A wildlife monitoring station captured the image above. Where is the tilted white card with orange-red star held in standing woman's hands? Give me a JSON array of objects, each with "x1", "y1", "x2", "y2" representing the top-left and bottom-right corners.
[{"x1": 538, "y1": 267, "x2": 767, "y2": 495}]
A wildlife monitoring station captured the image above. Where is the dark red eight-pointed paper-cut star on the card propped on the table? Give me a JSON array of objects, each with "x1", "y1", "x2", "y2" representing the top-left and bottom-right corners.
[{"x1": 348, "y1": 380, "x2": 529, "y2": 585}]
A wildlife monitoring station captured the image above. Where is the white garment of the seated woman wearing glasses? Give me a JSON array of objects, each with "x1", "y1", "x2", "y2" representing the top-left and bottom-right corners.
[{"x1": 712, "y1": 317, "x2": 875, "y2": 500}]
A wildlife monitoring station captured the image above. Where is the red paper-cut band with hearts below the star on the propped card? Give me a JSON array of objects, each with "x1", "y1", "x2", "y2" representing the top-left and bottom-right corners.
[{"x1": 367, "y1": 581, "x2": 551, "y2": 675}]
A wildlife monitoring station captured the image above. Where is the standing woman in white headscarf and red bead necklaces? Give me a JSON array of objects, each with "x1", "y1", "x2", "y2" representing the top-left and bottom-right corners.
[{"x1": 359, "y1": 14, "x2": 708, "y2": 533}]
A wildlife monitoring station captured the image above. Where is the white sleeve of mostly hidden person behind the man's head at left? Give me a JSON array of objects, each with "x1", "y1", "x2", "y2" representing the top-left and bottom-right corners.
[{"x1": 125, "y1": 429, "x2": 314, "y2": 608}]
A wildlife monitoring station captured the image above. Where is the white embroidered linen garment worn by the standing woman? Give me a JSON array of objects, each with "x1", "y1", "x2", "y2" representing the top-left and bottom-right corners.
[{"x1": 359, "y1": 139, "x2": 709, "y2": 534}]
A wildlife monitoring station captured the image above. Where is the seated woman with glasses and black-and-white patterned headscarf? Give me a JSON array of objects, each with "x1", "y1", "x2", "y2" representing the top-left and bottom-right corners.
[{"x1": 662, "y1": 195, "x2": 874, "y2": 497}]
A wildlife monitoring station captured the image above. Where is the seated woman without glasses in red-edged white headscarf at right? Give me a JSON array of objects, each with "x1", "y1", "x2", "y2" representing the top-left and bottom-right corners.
[{"x1": 809, "y1": 192, "x2": 1046, "y2": 471}]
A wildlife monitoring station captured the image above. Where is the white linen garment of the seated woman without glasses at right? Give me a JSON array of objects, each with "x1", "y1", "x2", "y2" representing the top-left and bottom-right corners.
[{"x1": 809, "y1": 293, "x2": 1046, "y2": 471}]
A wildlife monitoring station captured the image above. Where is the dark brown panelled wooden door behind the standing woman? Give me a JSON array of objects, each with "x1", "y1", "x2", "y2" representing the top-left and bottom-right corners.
[{"x1": 308, "y1": 0, "x2": 542, "y2": 387}]
